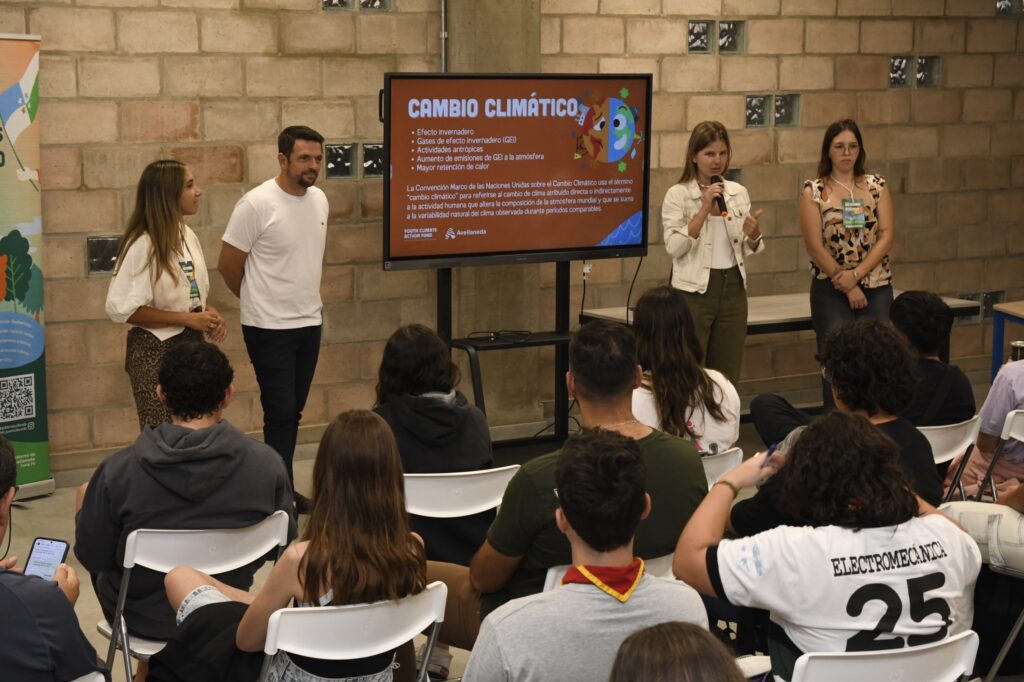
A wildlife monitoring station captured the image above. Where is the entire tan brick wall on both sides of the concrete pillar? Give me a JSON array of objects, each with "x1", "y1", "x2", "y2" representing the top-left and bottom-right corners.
[{"x1": 0, "y1": 0, "x2": 1024, "y2": 469}]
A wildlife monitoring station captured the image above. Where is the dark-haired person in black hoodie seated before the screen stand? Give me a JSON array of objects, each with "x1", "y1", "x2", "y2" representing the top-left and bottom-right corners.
[{"x1": 374, "y1": 325, "x2": 495, "y2": 566}]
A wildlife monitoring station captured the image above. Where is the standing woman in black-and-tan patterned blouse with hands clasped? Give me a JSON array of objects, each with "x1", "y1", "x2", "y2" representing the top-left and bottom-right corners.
[{"x1": 800, "y1": 119, "x2": 895, "y2": 407}]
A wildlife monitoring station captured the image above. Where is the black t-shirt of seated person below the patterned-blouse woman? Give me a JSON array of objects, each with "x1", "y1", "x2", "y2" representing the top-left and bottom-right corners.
[{"x1": 903, "y1": 357, "x2": 977, "y2": 426}]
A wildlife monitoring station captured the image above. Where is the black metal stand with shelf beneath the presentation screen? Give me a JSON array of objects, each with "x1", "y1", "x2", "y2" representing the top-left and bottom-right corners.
[{"x1": 437, "y1": 261, "x2": 570, "y2": 446}]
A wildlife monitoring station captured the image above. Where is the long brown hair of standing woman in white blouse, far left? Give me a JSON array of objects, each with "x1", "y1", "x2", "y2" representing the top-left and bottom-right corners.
[{"x1": 117, "y1": 159, "x2": 185, "y2": 282}]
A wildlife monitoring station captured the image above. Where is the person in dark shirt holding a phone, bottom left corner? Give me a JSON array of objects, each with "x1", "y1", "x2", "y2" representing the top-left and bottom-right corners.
[{"x1": 0, "y1": 436, "x2": 110, "y2": 682}]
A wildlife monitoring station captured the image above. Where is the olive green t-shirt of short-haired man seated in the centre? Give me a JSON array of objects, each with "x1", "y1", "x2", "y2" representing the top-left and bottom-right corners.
[{"x1": 480, "y1": 431, "x2": 708, "y2": 621}]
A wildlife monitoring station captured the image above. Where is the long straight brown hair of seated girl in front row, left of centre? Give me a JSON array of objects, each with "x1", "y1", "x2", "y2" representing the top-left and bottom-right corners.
[{"x1": 299, "y1": 410, "x2": 427, "y2": 604}]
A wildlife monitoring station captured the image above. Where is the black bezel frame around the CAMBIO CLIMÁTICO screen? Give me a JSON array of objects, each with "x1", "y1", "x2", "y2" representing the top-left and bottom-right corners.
[{"x1": 381, "y1": 73, "x2": 653, "y2": 270}]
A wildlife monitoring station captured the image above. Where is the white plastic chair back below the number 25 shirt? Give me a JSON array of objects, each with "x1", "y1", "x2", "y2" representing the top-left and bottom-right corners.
[{"x1": 791, "y1": 630, "x2": 978, "y2": 682}]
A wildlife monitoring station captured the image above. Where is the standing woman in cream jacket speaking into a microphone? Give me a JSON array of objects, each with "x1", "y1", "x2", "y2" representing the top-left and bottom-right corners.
[{"x1": 662, "y1": 121, "x2": 765, "y2": 384}]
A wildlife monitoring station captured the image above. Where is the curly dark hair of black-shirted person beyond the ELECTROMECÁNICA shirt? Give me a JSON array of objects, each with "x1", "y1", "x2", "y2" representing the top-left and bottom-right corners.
[{"x1": 816, "y1": 319, "x2": 918, "y2": 417}]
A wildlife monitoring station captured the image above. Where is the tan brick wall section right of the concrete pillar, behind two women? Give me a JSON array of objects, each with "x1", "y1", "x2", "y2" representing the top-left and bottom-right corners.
[{"x1": 541, "y1": 0, "x2": 1024, "y2": 393}]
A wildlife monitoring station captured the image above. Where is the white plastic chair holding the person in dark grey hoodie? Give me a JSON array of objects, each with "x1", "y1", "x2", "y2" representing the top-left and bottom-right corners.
[{"x1": 96, "y1": 510, "x2": 289, "y2": 680}]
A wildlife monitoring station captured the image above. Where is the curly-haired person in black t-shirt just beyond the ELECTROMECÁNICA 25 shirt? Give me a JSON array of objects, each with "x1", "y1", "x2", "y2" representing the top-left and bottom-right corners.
[{"x1": 730, "y1": 319, "x2": 942, "y2": 536}]
